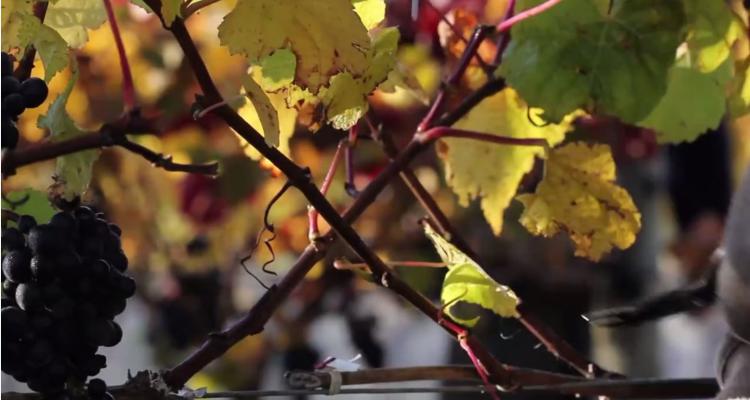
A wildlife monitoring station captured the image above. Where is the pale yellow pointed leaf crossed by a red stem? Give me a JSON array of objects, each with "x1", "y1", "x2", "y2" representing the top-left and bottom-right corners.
[{"x1": 446, "y1": 88, "x2": 572, "y2": 235}]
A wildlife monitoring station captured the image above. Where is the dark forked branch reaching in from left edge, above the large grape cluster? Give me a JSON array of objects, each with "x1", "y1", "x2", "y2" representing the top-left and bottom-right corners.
[{"x1": 0, "y1": 113, "x2": 219, "y2": 179}]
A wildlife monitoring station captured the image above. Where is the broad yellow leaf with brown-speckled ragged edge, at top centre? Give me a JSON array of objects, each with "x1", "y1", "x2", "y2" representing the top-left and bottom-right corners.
[{"x1": 219, "y1": 0, "x2": 370, "y2": 93}]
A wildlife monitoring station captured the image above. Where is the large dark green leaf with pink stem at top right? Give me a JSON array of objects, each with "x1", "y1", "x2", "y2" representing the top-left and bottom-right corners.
[{"x1": 499, "y1": 0, "x2": 685, "y2": 123}]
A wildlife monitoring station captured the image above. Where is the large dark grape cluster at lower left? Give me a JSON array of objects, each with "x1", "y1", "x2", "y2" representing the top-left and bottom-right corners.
[{"x1": 1, "y1": 206, "x2": 135, "y2": 400}]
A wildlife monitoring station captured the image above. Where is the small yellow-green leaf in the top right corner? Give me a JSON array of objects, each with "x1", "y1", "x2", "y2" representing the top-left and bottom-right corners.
[{"x1": 683, "y1": 0, "x2": 744, "y2": 72}]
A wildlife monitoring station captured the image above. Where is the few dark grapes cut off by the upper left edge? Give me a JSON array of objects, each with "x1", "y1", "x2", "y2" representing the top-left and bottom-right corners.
[{"x1": 0, "y1": 52, "x2": 49, "y2": 149}]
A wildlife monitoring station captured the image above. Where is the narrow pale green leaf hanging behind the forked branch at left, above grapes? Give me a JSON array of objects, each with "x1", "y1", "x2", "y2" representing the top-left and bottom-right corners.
[{"x1": 37, "y1": 59, "x2": 99, "y2": 200}]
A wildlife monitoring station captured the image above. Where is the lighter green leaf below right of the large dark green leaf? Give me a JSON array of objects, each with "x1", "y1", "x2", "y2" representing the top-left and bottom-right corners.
[{"x1": 638, "y1": 58, "x2": 732, "y2": 143}]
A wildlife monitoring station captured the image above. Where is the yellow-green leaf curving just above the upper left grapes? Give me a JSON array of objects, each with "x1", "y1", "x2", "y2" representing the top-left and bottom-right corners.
[{"x1": 2, "y1": 11, "x2": 69, "y2": 82}]
